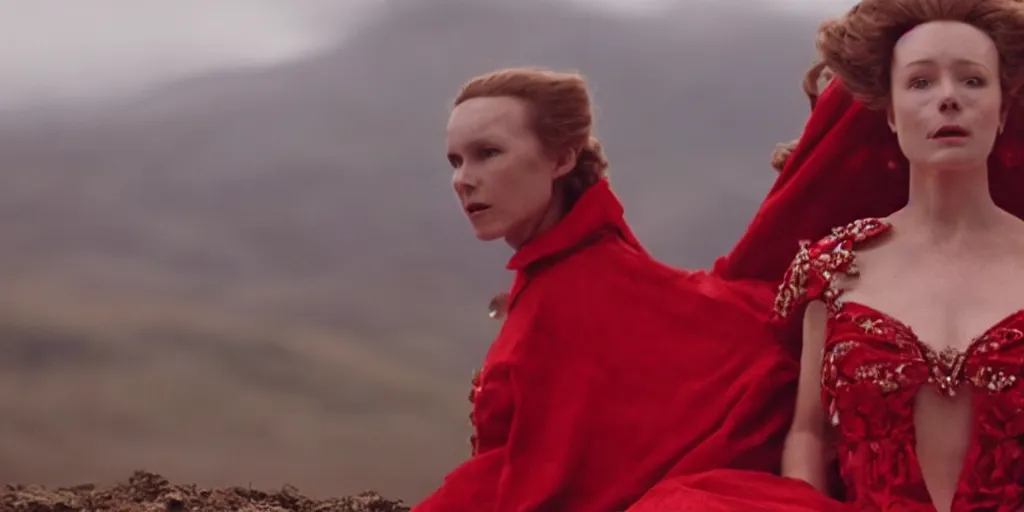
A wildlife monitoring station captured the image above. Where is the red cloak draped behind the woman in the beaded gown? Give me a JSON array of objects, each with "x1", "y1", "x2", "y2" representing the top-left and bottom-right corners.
[{"x1": 629, "y1": 80, "x2": 1024, "y2": 512}]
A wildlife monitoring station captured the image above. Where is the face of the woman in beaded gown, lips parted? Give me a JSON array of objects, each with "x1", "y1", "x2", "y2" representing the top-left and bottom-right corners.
[{"x1": 889, "y1": 22, "x2": 1004, "y2": 170}]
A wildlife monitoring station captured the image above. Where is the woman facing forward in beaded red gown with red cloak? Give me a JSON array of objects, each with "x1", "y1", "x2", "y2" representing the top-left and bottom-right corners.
[{"x1": 630, "y1": 0, "x2": 1024, "y2": 512}]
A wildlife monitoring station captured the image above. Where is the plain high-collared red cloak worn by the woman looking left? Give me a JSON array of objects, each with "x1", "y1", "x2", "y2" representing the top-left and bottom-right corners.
[{"x1": 414, "y1": 181, "x2": 798, "y2": 512}]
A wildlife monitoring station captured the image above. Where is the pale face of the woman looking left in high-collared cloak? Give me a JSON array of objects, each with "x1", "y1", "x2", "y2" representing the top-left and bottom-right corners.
[{"x1": 447, "y1": 96, "x2": 575, "y2": 248}]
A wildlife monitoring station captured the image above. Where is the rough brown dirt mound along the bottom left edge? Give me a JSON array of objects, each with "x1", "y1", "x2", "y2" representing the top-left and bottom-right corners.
[{"x1": 0, "y1": 471, "x2": 409, "y2": 512}]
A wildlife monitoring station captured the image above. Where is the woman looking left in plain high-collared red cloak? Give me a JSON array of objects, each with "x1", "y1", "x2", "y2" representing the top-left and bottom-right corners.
[{"x1": 414, "y1": 69, "x2": 797, "y2": 512}]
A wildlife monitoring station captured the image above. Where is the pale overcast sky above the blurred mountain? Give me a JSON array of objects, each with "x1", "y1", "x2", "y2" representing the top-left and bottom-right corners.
[{"x1": 0, "y1": 0, "x2": 853, "y2": 106}]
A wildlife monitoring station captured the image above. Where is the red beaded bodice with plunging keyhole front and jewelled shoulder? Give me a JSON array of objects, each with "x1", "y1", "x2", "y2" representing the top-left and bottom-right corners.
[{"x1": 775, "y1": 218, "x2": 1024, "y2": 512}]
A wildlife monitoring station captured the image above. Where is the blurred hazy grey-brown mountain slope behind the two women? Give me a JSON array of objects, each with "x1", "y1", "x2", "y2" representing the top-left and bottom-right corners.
[{"x1": 0, "y1": 0, "x2": 816, "y2": 500}]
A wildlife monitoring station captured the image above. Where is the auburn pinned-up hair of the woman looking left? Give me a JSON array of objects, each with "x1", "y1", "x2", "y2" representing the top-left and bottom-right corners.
[{"x1": 455, "y1": 68, "x2": 608, "y2": 208}]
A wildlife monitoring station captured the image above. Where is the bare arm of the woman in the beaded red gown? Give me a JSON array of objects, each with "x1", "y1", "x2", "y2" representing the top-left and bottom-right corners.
[{"x1": 782, "y1": 301, "x2": 828, "y2": 494}]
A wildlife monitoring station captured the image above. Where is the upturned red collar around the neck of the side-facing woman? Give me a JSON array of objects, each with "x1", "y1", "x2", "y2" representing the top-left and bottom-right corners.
[{"x1": 507, "y1": 179, "x2": 643, "y2": 271}]
